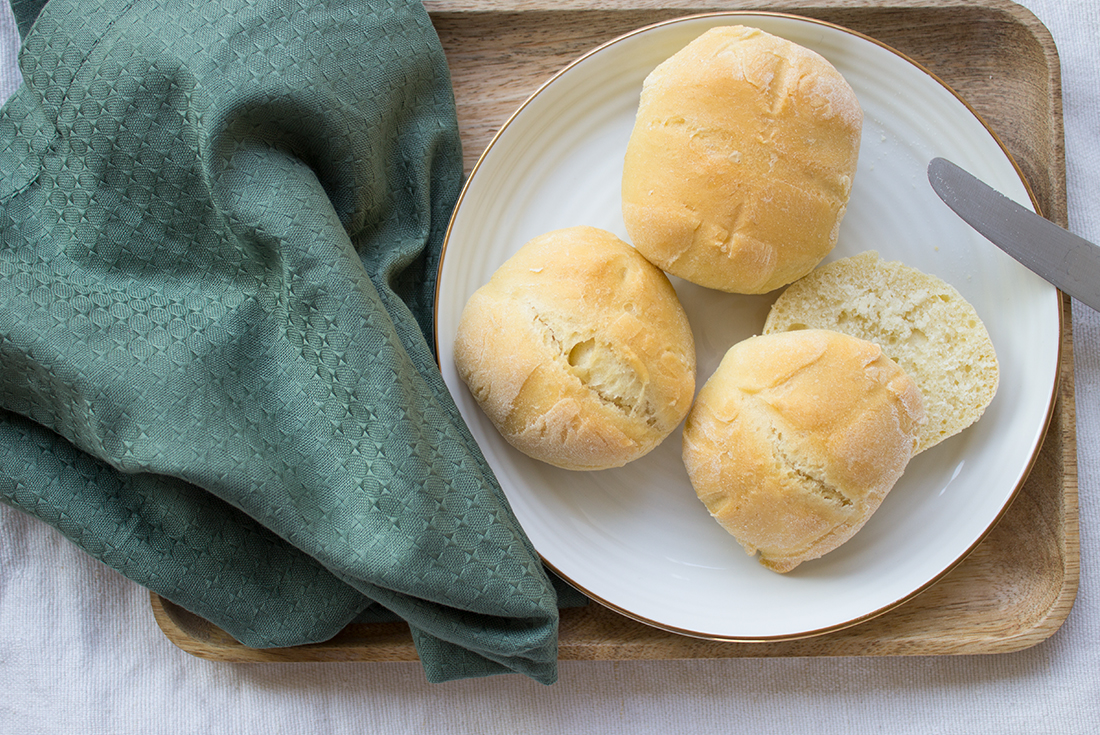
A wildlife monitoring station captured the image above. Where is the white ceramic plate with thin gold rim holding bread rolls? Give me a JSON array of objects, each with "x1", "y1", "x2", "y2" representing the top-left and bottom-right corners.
[{"x1": 437, "y1": 13, "x2": 1062, "y2": 640}]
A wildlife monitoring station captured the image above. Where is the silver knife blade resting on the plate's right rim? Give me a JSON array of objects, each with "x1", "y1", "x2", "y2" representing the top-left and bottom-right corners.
[{"x1": 928, "y1": 158, "x2": 1100, "y2": 310}]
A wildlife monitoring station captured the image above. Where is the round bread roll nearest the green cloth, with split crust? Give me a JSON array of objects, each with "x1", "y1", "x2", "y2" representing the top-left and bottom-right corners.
[{"x1": 454, "y1": 227, "x2": 695, "y2": 470}]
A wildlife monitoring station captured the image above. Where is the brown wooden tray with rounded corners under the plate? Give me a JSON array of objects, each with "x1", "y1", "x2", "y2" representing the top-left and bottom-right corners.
[{"x1": 152, "y1": 0, "x2": 1079, "y2": 661}]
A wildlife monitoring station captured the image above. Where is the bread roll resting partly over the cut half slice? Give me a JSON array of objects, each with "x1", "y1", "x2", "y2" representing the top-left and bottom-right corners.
[{"x1": 683, "y1": 330, "x2": 924, "y2": 572}]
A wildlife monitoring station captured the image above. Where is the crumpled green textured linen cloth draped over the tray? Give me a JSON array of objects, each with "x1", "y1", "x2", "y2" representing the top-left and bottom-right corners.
[{"x1": 0, "y1": 0, "x2": 580, "y2": 683}]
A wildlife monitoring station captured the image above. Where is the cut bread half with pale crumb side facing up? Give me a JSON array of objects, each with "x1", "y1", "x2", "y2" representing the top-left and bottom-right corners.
[{"x1": 763, "y1": 251, "x2": 1000, "y2": 452}]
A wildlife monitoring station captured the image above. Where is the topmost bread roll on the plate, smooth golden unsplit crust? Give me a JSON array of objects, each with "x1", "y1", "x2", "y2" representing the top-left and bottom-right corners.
[{"x1": 623, "y1": 26, "x2": 864, "y2": 294}]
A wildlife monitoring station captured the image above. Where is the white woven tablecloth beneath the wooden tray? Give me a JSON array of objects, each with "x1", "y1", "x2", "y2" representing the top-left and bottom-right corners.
[{"x1": 0, "y1": 0, "x2": 1100, "y2": 735}]
